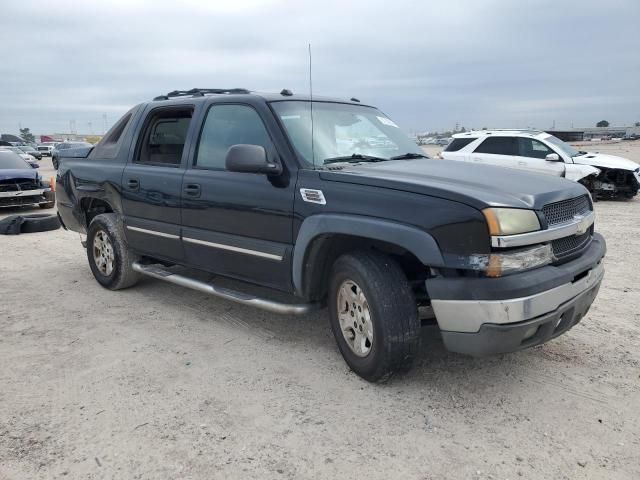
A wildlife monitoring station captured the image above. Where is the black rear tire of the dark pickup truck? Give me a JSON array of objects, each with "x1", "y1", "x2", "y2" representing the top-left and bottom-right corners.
[{"x1": 87, "y1": 213, "x2": 140, "y2": 290}]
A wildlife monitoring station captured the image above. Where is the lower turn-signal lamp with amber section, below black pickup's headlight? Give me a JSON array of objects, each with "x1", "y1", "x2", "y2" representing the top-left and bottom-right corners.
[{"x1": 468, "y1": 244, "x2": 554, "y2": 277}]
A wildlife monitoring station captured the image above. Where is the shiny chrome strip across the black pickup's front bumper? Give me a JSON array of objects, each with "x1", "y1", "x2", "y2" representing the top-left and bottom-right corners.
[{"x1": 431, "y1": 261, "x2": 604, "y2": 333}]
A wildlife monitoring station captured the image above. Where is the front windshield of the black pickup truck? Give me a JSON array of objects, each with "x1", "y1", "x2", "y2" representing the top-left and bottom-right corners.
[{"x1": 271, "y1": 100, "x2": 426, "y2": 168}]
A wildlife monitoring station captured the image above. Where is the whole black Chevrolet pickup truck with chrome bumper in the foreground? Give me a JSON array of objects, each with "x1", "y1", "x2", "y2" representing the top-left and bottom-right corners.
[{"x1": 57, "y1": 89, "x2": 606, "y2": 381}]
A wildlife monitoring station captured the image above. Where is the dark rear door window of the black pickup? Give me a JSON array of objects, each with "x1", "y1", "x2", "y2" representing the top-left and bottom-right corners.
[{"x1": 135, "y1": 108, "x2": 193, "y2": 167}]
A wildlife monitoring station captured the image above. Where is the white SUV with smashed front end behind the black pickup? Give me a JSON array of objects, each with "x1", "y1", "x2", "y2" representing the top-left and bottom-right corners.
[{"x1": 441, "y1": 130, "x2": 640, "y2": 198}]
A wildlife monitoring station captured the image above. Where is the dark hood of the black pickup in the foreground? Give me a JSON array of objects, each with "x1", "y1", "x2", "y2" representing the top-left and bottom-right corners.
[{"x1": 320, "y1": 158, "x2": 588, "y2": 209}]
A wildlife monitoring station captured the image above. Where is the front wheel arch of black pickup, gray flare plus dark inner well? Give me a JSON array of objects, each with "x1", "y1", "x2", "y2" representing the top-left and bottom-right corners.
[{"x1": 292, "y1": 214, "x2": 444, "y2": 300}]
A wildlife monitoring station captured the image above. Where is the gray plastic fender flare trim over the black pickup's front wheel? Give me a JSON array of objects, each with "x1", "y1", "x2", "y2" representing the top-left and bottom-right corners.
[{"x1": 292, "y1": 214, "x2": 444, "y2": 293}]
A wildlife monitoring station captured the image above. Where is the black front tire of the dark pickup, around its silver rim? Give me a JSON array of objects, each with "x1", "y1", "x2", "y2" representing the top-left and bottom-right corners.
[{"x1": 327, "y1": 251, "x2": 420, "y2": 382}]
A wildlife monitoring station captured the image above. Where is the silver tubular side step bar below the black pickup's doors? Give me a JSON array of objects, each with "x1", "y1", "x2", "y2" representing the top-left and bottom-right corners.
[{"x1": 131, "y1": 262, "x2": 320, "y2": 315}]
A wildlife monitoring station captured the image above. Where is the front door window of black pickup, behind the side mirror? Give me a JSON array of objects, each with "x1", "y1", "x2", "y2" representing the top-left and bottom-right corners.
[{"x1": 195, "y1": 105, "x2": 272, "y2": 170}]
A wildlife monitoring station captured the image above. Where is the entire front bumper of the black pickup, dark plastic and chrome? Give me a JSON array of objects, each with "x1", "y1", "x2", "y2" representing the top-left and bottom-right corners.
[{"x1": 427, "y1": 234, "x2": 606, "y2": 355}]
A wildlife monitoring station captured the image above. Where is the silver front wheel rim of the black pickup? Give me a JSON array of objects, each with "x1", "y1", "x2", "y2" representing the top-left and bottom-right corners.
[{"x1": 337, "y1": 280, "x2": 373, "y2": 357}]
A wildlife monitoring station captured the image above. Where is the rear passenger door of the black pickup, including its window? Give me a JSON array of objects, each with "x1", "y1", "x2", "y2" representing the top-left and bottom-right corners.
[{"x1": 122, "y1": 105, "x2": 193, "y2": 260}]
